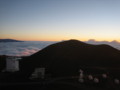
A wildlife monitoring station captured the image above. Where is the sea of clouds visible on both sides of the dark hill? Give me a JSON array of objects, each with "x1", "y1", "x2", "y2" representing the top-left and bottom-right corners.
[{"x1": 0, "y1": 39, "x2": 120, "y2": 56}]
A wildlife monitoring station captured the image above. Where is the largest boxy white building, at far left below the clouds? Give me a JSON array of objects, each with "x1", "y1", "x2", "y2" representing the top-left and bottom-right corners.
[{"x1": 6, "y1": 56, "x2": 21, "y2": 72}]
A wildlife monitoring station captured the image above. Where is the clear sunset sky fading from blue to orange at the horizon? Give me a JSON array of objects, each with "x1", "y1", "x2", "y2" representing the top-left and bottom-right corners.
[{"x1": 0, "y1": 0, "x2": 120, "y2": 41}]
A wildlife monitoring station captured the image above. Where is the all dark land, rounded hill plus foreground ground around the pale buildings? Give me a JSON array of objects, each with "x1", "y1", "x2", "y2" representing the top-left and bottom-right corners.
[{"x1": 0, "y1": 40, "x2": 120, "y2": 90}]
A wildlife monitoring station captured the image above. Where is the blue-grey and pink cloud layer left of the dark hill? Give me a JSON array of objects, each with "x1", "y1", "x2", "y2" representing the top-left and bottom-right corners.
[{"x1": 0, "y1": 41, "x2": 55, "y2": 56}]
